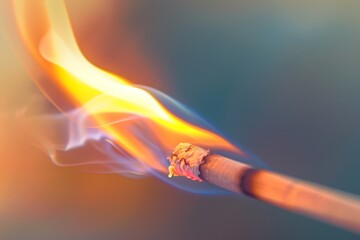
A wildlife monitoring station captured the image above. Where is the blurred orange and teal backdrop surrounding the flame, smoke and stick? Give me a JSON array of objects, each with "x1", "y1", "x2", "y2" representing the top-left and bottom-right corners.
[{"x1": 0, "y1": 0, "x2": 360, "y2": 240}]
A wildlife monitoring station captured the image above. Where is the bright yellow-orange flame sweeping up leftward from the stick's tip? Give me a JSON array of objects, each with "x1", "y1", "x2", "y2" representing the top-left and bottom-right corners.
[{"x1": 9, "y1": 0, "x2": 240, "y2": 172}]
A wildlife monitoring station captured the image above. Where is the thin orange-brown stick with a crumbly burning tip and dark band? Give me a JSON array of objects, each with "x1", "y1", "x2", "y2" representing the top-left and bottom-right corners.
[{"x1": 168, "y1": 143, "x2": 360, "y2": 234}]
